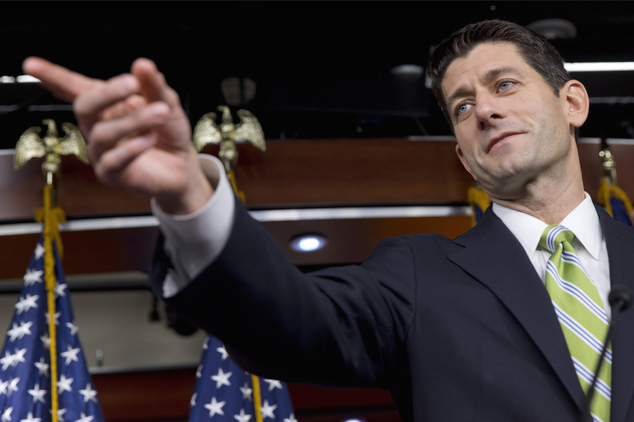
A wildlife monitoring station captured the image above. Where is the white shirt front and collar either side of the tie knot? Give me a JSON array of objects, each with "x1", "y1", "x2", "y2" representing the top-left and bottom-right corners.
[{"x1": 493, "y1": 193, "x2": 610, "y2": 317}]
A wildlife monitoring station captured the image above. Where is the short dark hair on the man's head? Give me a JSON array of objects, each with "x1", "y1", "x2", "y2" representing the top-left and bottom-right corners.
[{"x1": 427, "y1": 19, "x2": 571, "y2": 131}]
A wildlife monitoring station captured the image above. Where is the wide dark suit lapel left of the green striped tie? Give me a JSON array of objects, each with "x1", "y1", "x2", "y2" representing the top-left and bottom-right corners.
[{"x1": 449, "y1": 208, "x2": 584, "y2": 407}]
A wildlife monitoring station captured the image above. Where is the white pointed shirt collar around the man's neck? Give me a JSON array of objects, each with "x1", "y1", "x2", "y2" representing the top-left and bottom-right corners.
[{"x1": 493, "y1": 193, "x2": 603, "y2": 260}]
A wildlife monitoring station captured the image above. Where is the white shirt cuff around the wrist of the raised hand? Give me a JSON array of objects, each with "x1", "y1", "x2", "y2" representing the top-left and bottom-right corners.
[{"x1": 152, "y1": 154, "x2": 235, "y2": 298}]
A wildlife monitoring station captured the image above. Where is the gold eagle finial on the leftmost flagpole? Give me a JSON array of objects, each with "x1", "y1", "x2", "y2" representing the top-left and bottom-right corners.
[{"x1": 13, "y1": 119, "x2": 88, "y2": 174}]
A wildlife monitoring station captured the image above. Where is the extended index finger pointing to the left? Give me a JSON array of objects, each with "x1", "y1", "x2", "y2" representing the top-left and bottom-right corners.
[{"x1": 22, "y1": 57, "x2": 101, "y2": 102}]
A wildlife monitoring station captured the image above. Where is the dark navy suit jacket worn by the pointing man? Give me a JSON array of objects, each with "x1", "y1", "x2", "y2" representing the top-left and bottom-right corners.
[{"x1": 151, "y1": 201, "x2": 634, "y2": 422}]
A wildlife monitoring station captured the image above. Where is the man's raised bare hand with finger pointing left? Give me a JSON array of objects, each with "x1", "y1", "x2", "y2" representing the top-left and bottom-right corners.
[{"x1": 23, "y1": 57, "x2": 213, "y2": 215}]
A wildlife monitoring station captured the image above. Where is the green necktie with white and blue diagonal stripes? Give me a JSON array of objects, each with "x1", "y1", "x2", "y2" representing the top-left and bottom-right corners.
[{"x1": 539, "y1": 224, "x2": 612, "y2": 422}]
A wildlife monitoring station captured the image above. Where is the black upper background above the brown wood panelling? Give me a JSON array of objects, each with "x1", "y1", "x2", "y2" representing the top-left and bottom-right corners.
[{"x1": 0, "y1": 1, "x2": 634, "y2": 148}]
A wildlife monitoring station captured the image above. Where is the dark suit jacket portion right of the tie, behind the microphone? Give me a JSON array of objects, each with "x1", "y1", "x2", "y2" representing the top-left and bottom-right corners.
[{"x1": 597, "y1": 207, "x2": 634, "y2": 422}]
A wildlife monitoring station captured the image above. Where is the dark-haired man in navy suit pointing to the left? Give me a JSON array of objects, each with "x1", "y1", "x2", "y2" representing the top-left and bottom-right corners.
[{"x1": 24, "y1": 21, "x2": 634, "y2": 422}]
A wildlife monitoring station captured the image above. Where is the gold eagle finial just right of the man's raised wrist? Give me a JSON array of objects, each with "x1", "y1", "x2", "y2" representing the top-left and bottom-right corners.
[{"x1": 194, "y1": 106, "x2": 266, "y2": 171}]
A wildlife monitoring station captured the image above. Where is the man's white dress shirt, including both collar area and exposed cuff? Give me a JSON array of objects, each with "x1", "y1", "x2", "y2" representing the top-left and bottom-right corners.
[{"x1": 152, "y1": 154, "x2": 610, "y2": 316}]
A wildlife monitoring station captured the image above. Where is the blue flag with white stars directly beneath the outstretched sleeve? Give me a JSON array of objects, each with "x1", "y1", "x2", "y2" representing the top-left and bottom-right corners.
[{"x1": 189, "y1": 336, "x2": 297, "y2": 422}]
